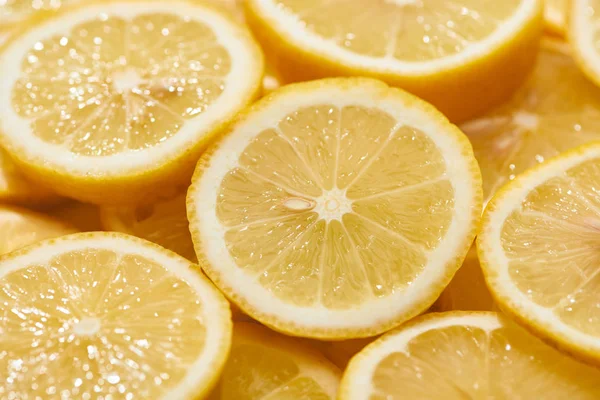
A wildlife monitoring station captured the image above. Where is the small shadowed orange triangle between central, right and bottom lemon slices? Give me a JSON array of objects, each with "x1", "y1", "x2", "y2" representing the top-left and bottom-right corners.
[{"x1": 434, "y1": 246, "x2": 497, "y2": 311}]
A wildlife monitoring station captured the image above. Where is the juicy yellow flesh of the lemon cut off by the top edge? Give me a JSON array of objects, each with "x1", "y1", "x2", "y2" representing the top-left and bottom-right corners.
[{"x1": 276, "y1": 0, "x2": 521, "y2": 62}]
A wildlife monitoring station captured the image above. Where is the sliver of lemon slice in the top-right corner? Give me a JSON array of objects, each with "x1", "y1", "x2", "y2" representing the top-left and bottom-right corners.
[{"x1": 569, "y1": 0, "x2": 600, "y2": 85}]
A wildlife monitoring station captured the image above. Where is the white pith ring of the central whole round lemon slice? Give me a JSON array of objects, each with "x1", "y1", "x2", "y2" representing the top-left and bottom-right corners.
[{"x1": 188, "y1": 84, "x2": 475, "y2": 329}]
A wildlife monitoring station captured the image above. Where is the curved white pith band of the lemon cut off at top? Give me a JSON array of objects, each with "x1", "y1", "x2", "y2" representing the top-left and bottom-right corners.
[{"x1": 251, "y1": 0, "x2": 540, "y2": 76}]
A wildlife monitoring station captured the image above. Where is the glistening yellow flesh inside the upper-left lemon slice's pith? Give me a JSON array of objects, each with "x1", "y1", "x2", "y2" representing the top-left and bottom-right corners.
[{"x1": 12, "y1": 13, "x2": 231, "y2": 156}]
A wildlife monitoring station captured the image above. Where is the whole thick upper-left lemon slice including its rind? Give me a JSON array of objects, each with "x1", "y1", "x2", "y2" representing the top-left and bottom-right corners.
[{"x1": 0, "y1": 0, "x2": 263, "y2": 203}]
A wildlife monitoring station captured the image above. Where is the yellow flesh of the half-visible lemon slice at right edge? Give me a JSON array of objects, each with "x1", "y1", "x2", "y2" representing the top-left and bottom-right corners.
[{"x1": 501, "y1": 160, "x2": 600, "y2": 337}]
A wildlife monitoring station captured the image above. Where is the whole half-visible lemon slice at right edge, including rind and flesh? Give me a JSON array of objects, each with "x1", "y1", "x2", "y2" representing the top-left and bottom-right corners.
[{"x1": 477, "y1": 144, "x2": 600, "y2": 365}]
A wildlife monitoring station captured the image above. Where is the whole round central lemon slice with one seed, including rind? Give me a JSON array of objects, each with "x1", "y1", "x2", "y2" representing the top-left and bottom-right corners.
[{"x1": 187, "y1": 78, "x2": 481, "y2": 339}]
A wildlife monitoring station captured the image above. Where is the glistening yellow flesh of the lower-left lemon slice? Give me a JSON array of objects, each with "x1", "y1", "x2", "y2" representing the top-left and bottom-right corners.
[{"x1": 0, "y1": 248, "x2": 205, "y2": 399}]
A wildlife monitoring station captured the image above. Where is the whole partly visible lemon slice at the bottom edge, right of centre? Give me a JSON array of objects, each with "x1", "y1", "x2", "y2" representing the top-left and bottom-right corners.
[{"x1": 339, "y1": 312, "x2": 600, "y2": 400}]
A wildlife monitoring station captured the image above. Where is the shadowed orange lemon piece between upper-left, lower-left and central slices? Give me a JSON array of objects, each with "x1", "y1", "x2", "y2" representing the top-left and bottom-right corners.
[{"x1": 101, "y1": 194, "x2": 197, "y2": 262}]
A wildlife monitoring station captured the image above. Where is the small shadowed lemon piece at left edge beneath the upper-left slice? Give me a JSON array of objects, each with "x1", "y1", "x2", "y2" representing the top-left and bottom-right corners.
[{"x1": 0, "y1": 149, "x2": 60, "y2": 206}]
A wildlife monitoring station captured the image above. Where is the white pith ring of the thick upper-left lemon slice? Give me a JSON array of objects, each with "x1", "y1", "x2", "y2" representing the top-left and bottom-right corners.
[{"x1": 0, "y1": 1, "x2": 258, "y2": 176}]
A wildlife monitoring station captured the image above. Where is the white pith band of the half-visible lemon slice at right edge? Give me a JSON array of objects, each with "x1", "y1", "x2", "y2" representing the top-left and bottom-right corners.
[{"x1": 478, "y1": 146, "x2": 600, "y2": 352}]
